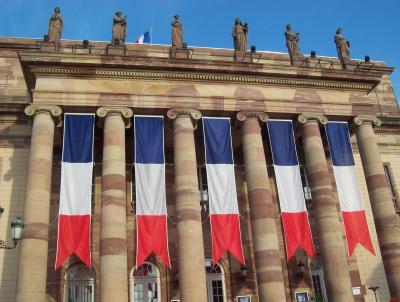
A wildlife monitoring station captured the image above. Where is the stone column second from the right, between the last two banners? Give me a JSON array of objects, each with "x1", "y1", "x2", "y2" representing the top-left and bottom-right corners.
[{"x1": 298, "y1": 114, "x2": 354, "y2": 302}]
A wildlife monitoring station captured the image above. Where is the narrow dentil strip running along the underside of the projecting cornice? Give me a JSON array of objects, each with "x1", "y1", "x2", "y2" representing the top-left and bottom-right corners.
[{"x1": 29, "y1": 65, "x2": 376, "y2": 91}]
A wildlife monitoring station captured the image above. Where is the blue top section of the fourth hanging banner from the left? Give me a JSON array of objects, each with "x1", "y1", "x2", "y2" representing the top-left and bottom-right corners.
[{"x1": 267, "y1": 120, "x2": 298, "y2": 166}]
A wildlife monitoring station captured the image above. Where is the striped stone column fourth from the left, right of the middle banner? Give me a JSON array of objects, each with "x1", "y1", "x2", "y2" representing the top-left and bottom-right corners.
[{"x1": 237, "y1": 111, "x2": 286, "y2": 302}]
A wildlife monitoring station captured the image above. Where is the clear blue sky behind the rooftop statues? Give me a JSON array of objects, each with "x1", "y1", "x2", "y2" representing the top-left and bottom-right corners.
[{"x1": 0, "y1": 0, "x2": 400, "y2": 96}]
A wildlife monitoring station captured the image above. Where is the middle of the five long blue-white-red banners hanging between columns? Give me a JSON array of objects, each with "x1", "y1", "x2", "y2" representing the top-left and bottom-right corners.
[{"x1": 203, "y1": 117, "x2": 244, "y2": 264}]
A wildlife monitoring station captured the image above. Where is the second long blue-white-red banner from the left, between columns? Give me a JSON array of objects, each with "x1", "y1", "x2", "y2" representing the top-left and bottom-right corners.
[{"x1": 134, "y1": 115, "x2": 171, "y2": 267}]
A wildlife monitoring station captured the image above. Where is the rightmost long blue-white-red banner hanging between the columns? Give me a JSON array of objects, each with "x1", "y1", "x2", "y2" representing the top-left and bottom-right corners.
[{"x1": 325, "y1": 122, "x2": 375, "y2": 256}]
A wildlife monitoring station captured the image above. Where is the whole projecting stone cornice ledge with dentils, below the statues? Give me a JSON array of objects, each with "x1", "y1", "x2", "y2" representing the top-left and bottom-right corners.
[{"x1": 19, "y1": 51, "x2": 392, "y2": 92}]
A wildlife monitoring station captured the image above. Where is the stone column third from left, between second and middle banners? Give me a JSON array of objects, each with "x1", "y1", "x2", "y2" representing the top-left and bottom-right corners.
[{"x1": 167, "y1": 109, "x2": 207, "y2": 302}]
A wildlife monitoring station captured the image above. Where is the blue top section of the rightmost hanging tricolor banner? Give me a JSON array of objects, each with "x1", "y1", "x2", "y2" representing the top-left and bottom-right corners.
[{"x1": 325, "y1": 122, "x2": 354, "y2": 166}]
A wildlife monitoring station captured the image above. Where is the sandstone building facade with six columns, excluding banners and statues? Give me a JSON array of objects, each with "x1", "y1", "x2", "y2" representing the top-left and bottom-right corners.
[{"x1": 0, "y1": 38, "x2": 400, "y2": 302}]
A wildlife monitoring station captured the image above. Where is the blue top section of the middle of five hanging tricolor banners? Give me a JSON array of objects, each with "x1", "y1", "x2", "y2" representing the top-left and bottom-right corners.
[{"x1": 203, "y1": 118, "x2": 233, "y2": 164}]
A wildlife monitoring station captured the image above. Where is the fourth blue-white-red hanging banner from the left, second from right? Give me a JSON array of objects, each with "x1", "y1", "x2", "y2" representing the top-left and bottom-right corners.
[{"x1": 267, "y1": 120, "x2": 315, "y2": 260}]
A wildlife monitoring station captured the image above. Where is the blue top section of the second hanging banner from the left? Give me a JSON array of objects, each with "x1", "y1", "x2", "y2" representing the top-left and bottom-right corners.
[{"x1": 135, "y1": 116, "x2": 165, "y2": 164}]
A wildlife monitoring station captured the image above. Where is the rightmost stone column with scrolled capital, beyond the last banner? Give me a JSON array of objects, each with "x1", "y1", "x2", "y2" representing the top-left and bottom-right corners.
[{"x1": 354, "y1": 116, "x2": 400, "y2": 300}]
